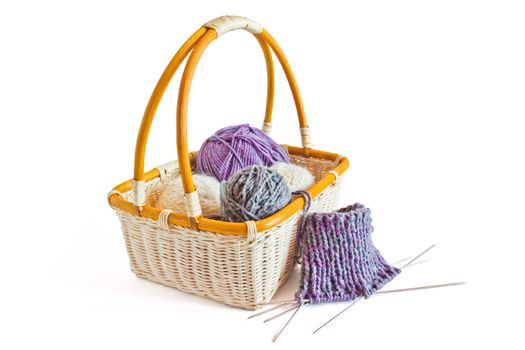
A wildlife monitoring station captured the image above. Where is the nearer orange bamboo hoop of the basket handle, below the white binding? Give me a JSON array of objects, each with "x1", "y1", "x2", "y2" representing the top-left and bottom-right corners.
[{"x1": 177, "y1": 29, "x2": 311, "y2": 220}]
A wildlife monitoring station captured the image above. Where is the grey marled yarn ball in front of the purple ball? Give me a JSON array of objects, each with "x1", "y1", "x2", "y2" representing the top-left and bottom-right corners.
[{"x1": 221, "y1": 165, "x2": 292, "y2": 222}]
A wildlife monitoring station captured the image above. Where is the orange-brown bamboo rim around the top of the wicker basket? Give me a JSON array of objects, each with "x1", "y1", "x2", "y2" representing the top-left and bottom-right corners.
[{"x1": 108, "y1": 145, "x2": 350, "y2": 235}]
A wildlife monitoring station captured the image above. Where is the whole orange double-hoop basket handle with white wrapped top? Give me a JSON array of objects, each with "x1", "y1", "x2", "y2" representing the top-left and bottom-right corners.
[{"x1": 132, "y1": 16, "x2": 311, "y2": 224}]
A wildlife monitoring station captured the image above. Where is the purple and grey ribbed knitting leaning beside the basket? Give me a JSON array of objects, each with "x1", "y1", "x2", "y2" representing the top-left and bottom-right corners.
[{"x1": 296, "y1": 203, "x2": 401, "y2": 304}]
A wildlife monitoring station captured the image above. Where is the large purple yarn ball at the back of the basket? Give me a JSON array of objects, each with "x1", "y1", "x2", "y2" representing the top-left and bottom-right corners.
[{"x1": 196, "y1": 124, "x2": 289, "y2": 181}]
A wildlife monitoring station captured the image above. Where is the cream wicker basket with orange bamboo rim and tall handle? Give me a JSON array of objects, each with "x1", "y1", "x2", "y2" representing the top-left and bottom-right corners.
[{"x1": 108, "y1": 16, "x2": 349, "y2": 309}]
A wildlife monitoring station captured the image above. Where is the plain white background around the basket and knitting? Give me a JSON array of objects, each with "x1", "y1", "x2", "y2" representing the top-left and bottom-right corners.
[{"x1": 0, "y1": 0, "x2": 525, "y2": 349}]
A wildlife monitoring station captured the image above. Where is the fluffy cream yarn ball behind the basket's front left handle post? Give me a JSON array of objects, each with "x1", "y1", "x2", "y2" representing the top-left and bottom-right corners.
[{"x1": 155, "y1": 174, "x2": 221, "y2": 217}]
